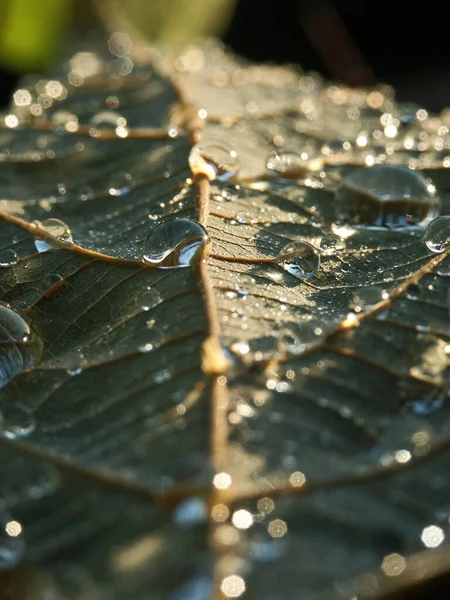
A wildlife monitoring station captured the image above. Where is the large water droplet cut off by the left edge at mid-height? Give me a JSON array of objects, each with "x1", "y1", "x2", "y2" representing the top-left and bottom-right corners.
[{"x1": 0, "y1": 305, "x2": 42, "y2": 388}]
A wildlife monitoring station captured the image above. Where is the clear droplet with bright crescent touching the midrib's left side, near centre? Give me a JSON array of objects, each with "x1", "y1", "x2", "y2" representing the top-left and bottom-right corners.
[{"x1": 143, "y1": 219, "x2": 208, "y2": 269}]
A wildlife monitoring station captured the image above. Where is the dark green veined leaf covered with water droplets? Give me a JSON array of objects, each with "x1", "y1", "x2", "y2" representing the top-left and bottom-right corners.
[{"x1": 0, "y1": 37, "x2": 450, "y2": 600}]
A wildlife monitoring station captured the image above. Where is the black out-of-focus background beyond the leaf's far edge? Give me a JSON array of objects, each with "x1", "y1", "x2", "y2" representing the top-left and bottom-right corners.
[{"x1": 0, "y1": 0, "x2": 450, "y2": 111}]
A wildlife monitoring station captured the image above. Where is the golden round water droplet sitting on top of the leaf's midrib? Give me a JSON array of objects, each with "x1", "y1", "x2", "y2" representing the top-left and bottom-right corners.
[{"x1": 189, "y1": 140, "x2": 240, "y2": 181}]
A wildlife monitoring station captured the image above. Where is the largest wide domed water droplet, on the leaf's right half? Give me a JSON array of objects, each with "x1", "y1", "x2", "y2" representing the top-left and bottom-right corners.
[{"x1": 336, "y1": 165, "x2": 440, "y2": 229}]
